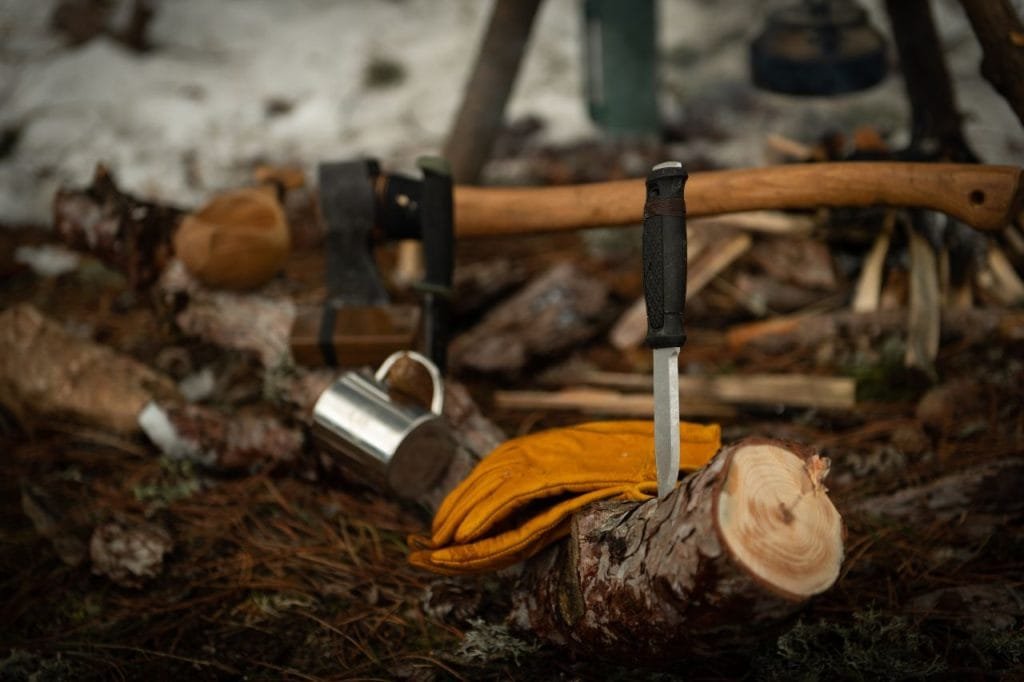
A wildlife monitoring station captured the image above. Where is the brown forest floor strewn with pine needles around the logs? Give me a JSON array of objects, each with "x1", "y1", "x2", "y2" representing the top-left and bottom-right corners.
[{"x1": 0, "y1": 134, "x2": 1024, "y2": 680}]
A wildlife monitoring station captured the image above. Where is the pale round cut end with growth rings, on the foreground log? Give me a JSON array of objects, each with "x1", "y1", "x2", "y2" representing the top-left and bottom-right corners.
[{"x1": 715, "y1": 440, "x2": 844, "y2": 600}]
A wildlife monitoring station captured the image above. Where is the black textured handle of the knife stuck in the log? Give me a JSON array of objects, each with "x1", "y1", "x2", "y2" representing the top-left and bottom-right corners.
[{"x1": 643, "y1": 163, "x2": 687, "y2": 348}]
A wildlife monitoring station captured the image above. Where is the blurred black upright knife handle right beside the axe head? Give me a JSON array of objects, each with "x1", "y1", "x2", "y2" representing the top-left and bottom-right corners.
[{"x1": 417, "y1": 157, "x2": 455, "y2": 374}]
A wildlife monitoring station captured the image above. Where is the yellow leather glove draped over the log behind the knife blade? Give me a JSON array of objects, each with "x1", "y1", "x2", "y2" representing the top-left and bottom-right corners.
[{"x1": 409, "y1": 421, "x2": 721, "y2": 574}]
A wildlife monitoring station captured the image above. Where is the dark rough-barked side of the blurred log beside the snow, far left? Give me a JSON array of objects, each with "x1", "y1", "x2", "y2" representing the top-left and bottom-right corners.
[{"x1": 53, "y1": 165, "x2": 182, "y2": 289}]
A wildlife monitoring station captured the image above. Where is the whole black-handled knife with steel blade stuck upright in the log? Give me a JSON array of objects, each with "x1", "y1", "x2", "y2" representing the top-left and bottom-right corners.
[{"x1": 642, "y1": 161, "x2": 687, "y2": 498}]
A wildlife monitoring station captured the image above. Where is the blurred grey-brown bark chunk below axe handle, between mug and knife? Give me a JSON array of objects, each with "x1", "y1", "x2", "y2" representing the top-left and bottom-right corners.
[{"x1": 451, "y1": 262, "x2": 608, "y2": 373}]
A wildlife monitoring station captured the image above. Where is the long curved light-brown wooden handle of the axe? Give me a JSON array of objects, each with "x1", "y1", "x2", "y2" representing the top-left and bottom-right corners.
[{"x1": 455, "y1": 161, "x2": 1024, "y2": 238}]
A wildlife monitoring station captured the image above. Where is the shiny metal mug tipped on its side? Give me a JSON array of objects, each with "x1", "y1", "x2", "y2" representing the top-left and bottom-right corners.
[{"x1": 312, "y1": 350, "x2": 455, "y2": 498}]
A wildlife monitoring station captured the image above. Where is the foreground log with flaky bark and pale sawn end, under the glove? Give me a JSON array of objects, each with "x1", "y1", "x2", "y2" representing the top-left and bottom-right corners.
[{"x1": 512, "y1": 439, "x2": 844, "y2": 663}]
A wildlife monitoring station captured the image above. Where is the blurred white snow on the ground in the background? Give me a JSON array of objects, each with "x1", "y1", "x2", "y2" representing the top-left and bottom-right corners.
[{"x1": 0, "y1": 0, "x2": 1024, "y2": 222}]
